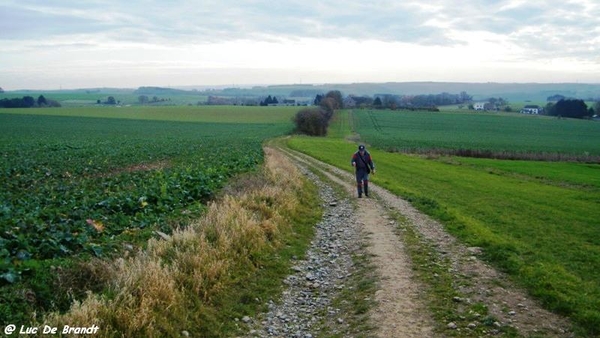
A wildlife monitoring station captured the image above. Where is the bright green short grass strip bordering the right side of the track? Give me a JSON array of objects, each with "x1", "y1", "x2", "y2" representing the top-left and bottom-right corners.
[{"x1": 289, "y1": 134, "x2": 600, "y2": 336}]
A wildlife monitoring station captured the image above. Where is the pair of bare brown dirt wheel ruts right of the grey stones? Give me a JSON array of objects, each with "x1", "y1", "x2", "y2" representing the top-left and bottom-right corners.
[{"x1": 285, "y1": 146, "x2": 574, "y2": 337}]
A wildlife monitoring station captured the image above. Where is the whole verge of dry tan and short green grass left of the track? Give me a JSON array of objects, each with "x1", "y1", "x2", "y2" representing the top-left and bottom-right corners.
[{"x1": 45, "y1": 148, "x2": 321, "y2": 337}]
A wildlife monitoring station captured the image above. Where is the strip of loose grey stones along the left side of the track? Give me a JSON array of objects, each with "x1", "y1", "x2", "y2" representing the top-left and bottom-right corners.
[{"x1": 242, "y1": 154, "x2": 362, "y2": 338}]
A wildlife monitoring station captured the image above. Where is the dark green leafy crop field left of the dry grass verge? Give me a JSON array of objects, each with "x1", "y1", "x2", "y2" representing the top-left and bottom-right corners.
[{"x1": 0, "y1": 107, "x2": 295, "y2": 324}]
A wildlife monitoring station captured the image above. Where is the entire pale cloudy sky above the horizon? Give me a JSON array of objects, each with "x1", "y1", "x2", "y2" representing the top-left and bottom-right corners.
[{"x1": 0, "y1": 0, "x2": 600, "y2": 90}]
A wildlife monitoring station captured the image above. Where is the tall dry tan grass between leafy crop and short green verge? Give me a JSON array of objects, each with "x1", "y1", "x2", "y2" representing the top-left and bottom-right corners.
[{"x1": 45, "y1": 149, "x2": 303, "y2": 337}]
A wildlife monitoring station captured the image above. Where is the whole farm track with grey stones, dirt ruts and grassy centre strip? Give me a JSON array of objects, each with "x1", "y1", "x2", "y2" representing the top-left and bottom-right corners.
[{"x1": 245, "y1": 149, "x2": 574, "y2": 337}]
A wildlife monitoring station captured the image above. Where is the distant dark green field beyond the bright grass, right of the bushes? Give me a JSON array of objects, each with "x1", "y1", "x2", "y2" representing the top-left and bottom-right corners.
[{"x1": 348, "y1": 110, "x2": 600, "y2": 159}]
